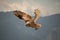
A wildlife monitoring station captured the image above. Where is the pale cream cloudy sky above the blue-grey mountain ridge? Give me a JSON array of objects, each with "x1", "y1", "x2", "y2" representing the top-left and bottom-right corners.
[{"x1": 0, "y1": 0, "x2": 60, "y2": 16}]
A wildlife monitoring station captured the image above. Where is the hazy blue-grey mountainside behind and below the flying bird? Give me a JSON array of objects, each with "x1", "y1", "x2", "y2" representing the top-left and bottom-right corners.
[{"x1": 0, "y1": 12, "x2": 60, "y2": 40}]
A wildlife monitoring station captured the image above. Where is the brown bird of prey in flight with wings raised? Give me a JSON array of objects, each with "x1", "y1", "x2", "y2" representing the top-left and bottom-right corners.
[{"x1": 13, "y1": 9, "x2": 41, "y2": 30}]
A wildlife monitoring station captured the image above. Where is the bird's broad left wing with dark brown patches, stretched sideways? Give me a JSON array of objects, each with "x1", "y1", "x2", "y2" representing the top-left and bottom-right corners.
[{"x1": 14, "y1": 10, "x2": 32, "y2": 22}]
